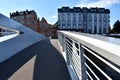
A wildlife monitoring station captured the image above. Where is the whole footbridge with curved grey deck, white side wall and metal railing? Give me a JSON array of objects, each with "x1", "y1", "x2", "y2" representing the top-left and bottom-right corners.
[{"x1": 0, "y1": 14, "x2": 120, "y2": 80}]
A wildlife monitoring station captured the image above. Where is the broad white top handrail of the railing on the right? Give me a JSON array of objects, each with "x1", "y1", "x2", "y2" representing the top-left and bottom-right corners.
[{"x1": 58, "y1": 31, "x2": 120, "y2": 66}]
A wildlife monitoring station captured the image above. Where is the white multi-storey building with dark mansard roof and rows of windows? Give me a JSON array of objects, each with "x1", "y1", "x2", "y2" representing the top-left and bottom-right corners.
[{"x1": 58, "y1": 7, "x2": 110, "y2": 34}]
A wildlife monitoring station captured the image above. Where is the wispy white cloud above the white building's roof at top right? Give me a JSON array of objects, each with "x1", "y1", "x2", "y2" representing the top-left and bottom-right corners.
[{"x1": 76, "y1": 0, "x2": 120, "y2": 8}]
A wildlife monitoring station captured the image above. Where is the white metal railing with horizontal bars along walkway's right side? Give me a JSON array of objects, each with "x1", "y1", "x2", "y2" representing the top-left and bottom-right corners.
[{"x1": 58, "y1": 31, "x2": 120, "y2": 80}]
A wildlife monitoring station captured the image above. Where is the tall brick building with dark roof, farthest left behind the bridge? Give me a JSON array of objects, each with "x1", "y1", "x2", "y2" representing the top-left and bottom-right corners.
[{"x1": 10, "y1": 10, "x2": 39, "y2": 31}]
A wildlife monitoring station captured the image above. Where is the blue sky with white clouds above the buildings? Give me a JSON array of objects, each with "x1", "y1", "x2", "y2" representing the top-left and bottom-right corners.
[{"x1": 0, "y1": 0, "x2": 120, "y2": 27}]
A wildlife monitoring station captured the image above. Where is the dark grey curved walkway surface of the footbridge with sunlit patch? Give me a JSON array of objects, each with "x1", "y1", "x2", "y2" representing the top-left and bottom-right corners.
[{"x1": 0, "y1": 39, "x2": 71, "y2": 80}]
